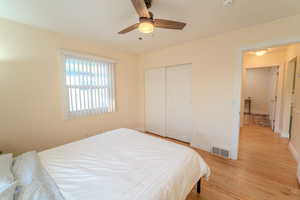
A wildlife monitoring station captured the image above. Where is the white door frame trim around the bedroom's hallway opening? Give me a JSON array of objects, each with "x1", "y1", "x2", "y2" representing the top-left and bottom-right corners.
[{"x1": 231, "y1": 36, "x2": 300, "y2": 160}]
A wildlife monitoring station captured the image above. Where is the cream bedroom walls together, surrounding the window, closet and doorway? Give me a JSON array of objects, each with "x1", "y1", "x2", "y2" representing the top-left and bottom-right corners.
[{"x1": 0, "y1": 15, "x2": 300, "y2": 161}]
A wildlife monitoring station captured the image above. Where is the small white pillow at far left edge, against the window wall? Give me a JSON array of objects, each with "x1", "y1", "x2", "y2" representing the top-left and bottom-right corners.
[{"x1": 0, "y1": 154, "x2": 14, "y2": 187}]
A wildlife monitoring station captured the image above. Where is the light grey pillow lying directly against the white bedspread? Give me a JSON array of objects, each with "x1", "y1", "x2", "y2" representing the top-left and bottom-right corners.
[{"x1": 13, "y1": 152, "x2": 64, "y2": 200}]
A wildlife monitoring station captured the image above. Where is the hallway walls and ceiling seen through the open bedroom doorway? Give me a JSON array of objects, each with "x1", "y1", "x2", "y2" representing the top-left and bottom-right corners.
[{"x1": 240, "y1": 43, "x2": 300, "y2": 138}]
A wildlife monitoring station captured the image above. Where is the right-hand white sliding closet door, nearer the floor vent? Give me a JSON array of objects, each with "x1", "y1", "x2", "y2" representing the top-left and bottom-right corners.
[{"x1": 166, "y1": 65, "x2": 193, "y2": 142}]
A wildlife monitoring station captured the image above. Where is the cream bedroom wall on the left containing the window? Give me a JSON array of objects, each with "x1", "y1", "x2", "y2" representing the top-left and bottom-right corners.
[{"x1": 0, "y1": 20, "x2": 138, "y2": 153}]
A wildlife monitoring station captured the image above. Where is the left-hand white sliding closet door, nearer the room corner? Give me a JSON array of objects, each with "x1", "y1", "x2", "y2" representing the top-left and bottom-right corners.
[{"x1": 145, "y1": 68, "x2": 166, "y2": 136}]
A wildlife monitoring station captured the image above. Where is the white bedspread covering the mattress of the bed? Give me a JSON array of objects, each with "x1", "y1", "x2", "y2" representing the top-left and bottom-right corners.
[{"x1": 39, "y1": 129, "x2": 210, "y2": 200}]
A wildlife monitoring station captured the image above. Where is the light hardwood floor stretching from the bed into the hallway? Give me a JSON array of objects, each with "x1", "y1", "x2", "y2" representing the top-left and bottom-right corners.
[{"x1": 187, "y1": 124, "x2": 300, "y2": 200}]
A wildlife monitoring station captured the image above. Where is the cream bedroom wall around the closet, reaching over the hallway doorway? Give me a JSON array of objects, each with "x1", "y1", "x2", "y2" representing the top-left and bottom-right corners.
[{"x1": 139, "y1": 16, "x2": 300, "y2": 158}]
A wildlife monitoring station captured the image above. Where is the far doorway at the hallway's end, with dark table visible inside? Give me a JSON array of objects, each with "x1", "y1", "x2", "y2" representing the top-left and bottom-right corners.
[{"x1": 243, "y1": 66, "x2": 280, "y2": 131}]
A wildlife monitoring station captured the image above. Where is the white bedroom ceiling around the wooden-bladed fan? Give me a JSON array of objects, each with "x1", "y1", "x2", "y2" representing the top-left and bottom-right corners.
[{"x1": 0, "y1": 0, "x2": 300, "y2": 53}]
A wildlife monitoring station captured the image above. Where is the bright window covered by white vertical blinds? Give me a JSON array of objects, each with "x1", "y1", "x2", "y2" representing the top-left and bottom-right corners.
[{"x1": 63, "y1": 51, "x2": 115, "y2": 118}]
